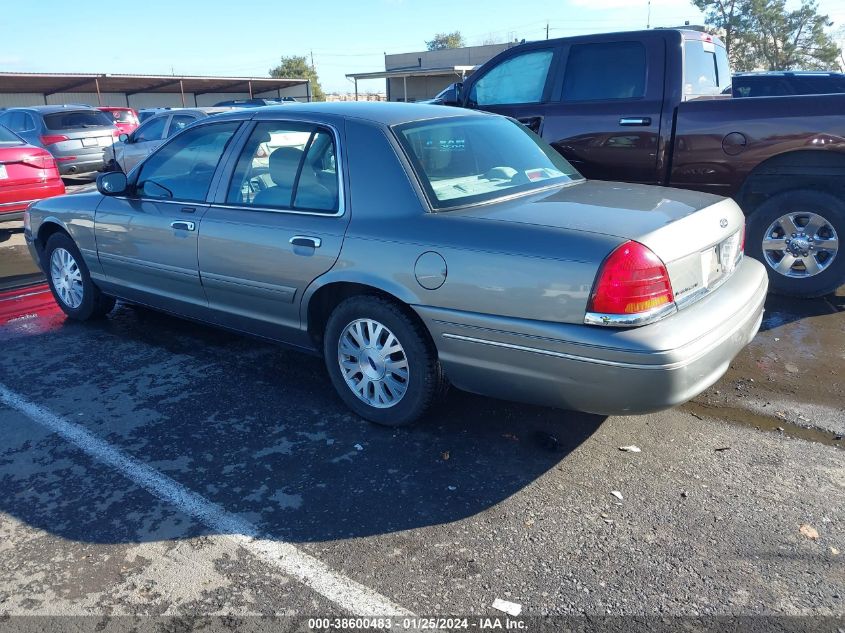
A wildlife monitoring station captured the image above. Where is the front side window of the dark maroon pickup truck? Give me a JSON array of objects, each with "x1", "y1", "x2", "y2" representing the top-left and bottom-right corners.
[{"x1": 469, "y1": 50, "x2": 553, "y2": 106}]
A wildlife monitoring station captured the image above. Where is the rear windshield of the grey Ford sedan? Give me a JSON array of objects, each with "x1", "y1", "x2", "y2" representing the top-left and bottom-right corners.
[{"x1": 394, "y1": 117, "x2": 582, "y2": 209}]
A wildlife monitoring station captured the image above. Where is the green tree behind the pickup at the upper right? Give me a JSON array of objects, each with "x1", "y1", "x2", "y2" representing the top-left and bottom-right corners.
[{"x1": 692, "y1": 0, "x2": 841, "y2": 70}]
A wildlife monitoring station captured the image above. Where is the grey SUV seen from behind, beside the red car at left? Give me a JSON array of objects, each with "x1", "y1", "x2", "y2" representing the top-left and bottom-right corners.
[{"x1": 0, "y1": 105, "x2": 118, "y2": 176}]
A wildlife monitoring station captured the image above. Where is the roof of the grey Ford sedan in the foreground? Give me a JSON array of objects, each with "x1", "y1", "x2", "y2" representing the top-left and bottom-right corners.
[{"x1": 206, "y1": 101, "x2": 492, "y2": 125}]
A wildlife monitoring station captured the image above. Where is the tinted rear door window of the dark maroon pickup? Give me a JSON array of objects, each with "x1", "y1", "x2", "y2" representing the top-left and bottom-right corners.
[{"x1": 563, "y1": 42, "x2": 646, "y2": 101}]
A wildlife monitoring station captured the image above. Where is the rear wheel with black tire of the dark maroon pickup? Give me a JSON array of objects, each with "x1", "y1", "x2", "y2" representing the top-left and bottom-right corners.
[{"x1": 746, "y1": 189, "x2": 845, "y2": 297}]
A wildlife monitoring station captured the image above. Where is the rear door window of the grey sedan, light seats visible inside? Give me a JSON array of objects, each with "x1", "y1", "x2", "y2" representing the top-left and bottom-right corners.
[{"x1": 226, "y1": 121, "x2": 339, "y2": 213}]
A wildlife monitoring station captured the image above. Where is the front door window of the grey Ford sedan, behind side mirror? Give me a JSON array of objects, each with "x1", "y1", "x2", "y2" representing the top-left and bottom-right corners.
[{"x1": 136, "y1": 121, "x2": 240, "y2": 202}]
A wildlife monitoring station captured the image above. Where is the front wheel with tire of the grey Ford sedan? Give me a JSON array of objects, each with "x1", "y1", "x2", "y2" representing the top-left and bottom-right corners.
[{"x1": 44, "y1": 233, "x2": 115, "y2": 321}]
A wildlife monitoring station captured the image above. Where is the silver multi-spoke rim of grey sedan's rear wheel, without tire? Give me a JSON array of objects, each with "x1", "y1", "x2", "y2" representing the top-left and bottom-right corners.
[{"x1": 337, "y1": 319, "x2": 410, "y2": 409}]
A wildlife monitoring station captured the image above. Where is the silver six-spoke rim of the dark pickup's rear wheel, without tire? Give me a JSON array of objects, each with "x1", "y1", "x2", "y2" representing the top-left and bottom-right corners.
[{"x1": 762, "y1": 212, "x2": 839, "y2": 278}]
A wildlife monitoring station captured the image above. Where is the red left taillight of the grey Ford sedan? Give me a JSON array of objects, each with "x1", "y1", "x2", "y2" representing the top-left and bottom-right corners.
[{"x1": 585, "y1": 242, "x2": 675, "y2": 326}]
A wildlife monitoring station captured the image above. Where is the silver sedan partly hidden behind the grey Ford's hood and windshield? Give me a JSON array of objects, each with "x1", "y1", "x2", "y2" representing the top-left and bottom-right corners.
[{"x1": 104, "y1": 108, "x2": 232, "y2": 173}]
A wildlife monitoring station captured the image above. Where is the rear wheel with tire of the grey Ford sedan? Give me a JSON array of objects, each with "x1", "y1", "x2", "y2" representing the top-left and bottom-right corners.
[{"x1": 323, "y1": 295, "x2": 445, "y2": 427}]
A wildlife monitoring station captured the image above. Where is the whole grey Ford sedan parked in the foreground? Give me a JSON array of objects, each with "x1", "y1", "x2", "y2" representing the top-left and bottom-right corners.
[{"x1": 25, "y1": 103, "x2": 767, "y2": 425}]
